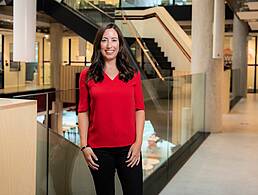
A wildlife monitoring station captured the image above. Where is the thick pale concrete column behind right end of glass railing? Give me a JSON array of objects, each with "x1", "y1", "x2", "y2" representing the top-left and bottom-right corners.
[{"x1": 191, "y1": 0, "x2": 224, "y2": 132}]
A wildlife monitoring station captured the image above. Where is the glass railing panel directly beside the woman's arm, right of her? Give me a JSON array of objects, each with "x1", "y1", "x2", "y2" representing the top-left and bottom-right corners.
[{"x1": 142, "y1": 79, "x2": 171, "y2": 180}]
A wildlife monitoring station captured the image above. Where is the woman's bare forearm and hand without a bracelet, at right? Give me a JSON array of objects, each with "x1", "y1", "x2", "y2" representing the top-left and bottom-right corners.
[{"x1": 126, "y1": 110, "x2": 145, "y2": 167}]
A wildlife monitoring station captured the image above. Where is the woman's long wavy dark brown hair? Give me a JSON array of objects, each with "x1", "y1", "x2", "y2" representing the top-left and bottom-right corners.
[{"x1": 87, "y1": 23, "x2": 137, "y2": 82}]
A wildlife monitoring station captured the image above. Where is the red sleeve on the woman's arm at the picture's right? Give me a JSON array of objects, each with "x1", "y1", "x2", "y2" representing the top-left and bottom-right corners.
[{"x1": 134, "y1": 72, "x2": 144, "y2": 110}]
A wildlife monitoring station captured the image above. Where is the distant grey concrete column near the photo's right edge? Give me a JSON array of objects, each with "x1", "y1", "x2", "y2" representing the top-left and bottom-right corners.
[{"x1": 232, "y1": 15, "x2": 248, "y2": 97}]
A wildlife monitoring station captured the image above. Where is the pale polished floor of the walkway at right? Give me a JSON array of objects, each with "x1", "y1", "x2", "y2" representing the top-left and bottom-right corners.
[{"x1": 160, "y1": 94, "x2": 258, "y2": 195}]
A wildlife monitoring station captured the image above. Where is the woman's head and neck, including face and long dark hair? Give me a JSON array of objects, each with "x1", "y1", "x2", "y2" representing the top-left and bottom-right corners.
[{"x1": 88, "y1": 23, "x2": 136, "y2": 82}]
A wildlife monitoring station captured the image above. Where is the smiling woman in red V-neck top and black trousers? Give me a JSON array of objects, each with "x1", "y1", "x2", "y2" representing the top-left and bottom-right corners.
[{"x1": 78, "y1": 24, "x2": 145, "y2": 195}]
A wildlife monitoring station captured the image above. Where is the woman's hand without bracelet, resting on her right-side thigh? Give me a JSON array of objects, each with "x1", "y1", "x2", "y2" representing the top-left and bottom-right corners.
[{"x1": 125, "y1": 142, "x2": 142, "y2": 168}]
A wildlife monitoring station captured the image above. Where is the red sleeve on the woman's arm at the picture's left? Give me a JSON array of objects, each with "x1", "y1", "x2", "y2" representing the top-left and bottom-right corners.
[{"x1": 78, "y1": 68, "x2": 89, "y2": 112}]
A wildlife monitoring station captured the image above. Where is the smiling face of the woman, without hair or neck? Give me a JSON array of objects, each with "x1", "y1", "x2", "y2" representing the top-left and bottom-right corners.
[{"x1": 100, "y1": 28, "x2": 119, "y2": 62}]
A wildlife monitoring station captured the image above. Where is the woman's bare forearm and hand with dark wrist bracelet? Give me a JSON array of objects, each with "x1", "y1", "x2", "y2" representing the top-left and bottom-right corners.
[{"x1": 78, "y1": 112, "x2": 99, "y2": 170}]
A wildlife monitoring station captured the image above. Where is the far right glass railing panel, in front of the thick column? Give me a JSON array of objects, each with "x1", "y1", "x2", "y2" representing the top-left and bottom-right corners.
[{"x1": 168, "y1": 74, "x2": 205, "y2": 149}]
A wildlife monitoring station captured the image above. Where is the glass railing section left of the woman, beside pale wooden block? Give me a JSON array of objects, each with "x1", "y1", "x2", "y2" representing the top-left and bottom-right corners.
[{"x1": 14, "y1": 89, "x2": 122, "y2": 195}]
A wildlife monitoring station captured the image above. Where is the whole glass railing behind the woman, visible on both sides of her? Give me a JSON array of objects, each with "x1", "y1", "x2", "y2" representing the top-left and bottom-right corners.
[{"x1": 12, "y1": 71, "x2": 205, "y2": 195}]
